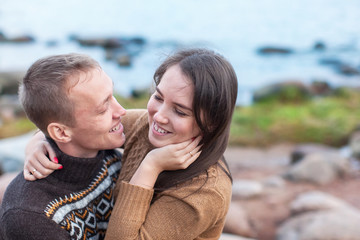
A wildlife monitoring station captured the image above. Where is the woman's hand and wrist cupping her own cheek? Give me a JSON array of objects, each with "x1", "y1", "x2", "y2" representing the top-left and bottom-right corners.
[{"x1": 129, "y1": 136, "x2": 201, "y2": 189}]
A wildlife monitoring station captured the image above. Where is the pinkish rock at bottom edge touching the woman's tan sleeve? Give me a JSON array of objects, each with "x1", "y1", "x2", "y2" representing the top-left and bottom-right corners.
[{"x1": 223, "y1": 202, "x2": 256, "y2": 237}]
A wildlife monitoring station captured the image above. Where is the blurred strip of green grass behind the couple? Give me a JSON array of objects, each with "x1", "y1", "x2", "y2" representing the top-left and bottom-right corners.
[{"x1": 0, "y1": 89, "x2": 360, "y2": 146}]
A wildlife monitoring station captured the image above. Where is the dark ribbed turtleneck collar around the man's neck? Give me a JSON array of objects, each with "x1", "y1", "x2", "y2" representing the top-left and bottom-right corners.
[{"x1": 47, "y1": 138, "x2": 105, "y2": 184}]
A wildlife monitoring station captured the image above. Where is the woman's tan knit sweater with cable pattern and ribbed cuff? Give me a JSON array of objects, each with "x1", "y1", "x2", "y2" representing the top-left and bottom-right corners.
[{"x1": 105, "y1": 110, "x2": 231, "y2": 240}]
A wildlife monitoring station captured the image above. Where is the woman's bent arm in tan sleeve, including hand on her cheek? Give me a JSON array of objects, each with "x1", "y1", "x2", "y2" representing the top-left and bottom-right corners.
[{"x1": 102, "y1": 137, "x2": 231, "y2": 240}]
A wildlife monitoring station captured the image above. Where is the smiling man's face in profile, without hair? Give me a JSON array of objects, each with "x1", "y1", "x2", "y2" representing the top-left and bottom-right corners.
[{"x1": 69, "y1": 68, "x2": 126, "y2": 157}]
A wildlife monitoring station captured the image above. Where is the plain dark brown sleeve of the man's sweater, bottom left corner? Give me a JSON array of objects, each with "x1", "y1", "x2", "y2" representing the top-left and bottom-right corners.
[{"x1": 0, "y1": 209, "x2": 70, "y2": 240}]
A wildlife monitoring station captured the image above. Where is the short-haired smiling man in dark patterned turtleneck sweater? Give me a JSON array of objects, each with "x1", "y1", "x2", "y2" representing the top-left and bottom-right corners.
[{"x1": 0, "y1": 54, "x2": 126, "y2": 240}]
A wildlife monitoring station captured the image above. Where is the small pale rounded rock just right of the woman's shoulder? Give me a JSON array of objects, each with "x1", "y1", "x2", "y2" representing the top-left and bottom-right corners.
[{"x1": 232, "y1": 180, "x2": 264, "y2": 198}]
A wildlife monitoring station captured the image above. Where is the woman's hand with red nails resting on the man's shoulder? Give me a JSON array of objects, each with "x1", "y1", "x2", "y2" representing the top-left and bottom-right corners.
[{"x1": 24, "y1": 131, "x2": 62, "y2": 181}]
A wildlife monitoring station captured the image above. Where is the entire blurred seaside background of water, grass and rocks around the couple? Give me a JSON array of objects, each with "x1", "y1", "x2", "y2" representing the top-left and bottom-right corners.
[{"x1": 0, "y1": 0, "x2": 360, "y2": 236}]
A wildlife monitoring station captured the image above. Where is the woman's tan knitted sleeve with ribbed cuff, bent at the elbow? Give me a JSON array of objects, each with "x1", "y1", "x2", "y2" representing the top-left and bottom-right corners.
[{"x1": 105, "y1": 171, "x2": 228, "y2": 240}]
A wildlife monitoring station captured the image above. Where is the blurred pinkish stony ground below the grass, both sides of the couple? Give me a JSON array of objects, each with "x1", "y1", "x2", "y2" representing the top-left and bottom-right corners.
[{"x1": 0, "y1": 133, "x2": 360, "y2": 240}]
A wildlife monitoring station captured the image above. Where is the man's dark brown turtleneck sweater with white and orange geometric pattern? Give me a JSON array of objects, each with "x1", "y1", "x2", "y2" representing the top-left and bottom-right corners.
[{"x1": 0, "y1": 138, "x2": 121, "y2": 240}]
